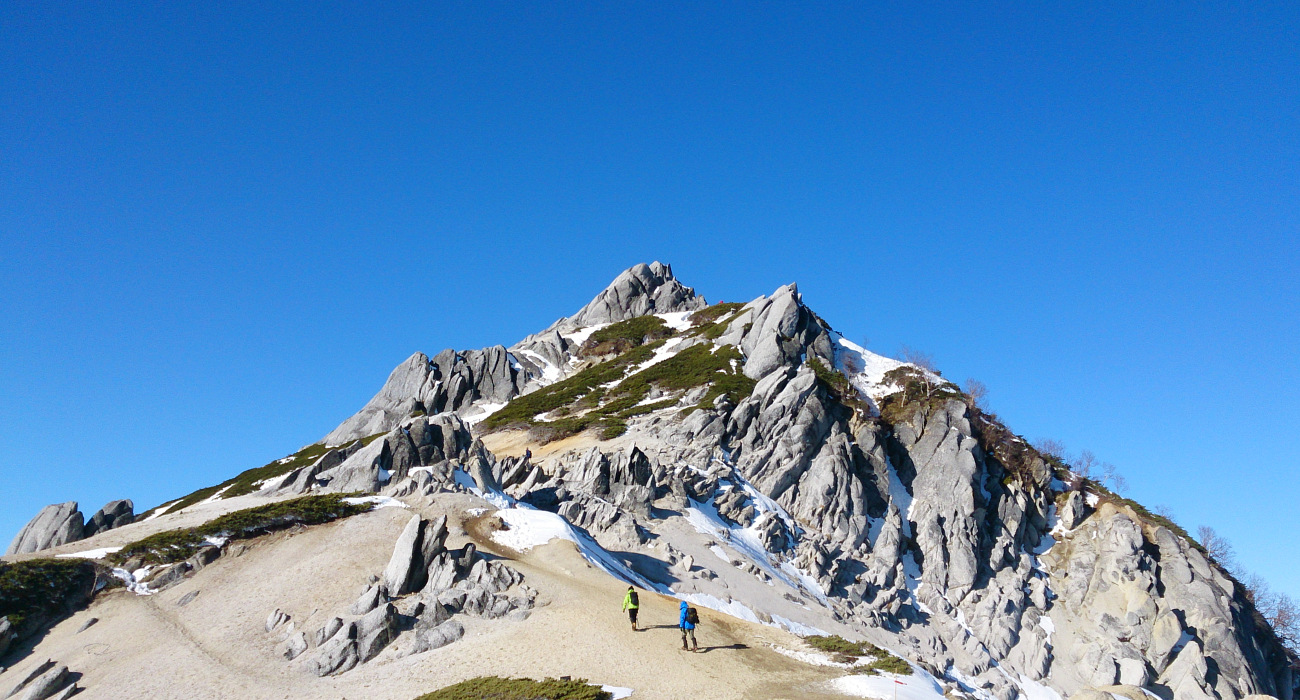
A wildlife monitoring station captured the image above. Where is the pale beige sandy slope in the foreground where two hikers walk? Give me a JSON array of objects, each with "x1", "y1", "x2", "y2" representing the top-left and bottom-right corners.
[{"x1": 0, "y1": 493, "x2": 868, "y2": 700}]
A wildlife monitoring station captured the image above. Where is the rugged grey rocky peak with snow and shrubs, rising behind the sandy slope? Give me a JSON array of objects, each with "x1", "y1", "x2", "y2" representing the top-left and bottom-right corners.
[{"x1": 5, "y1": 263, "x2": 1295, "y2": 700}]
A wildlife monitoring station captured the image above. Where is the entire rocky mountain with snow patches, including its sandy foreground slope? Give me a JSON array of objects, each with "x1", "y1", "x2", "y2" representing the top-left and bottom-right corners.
[{"x1": 0, "y1": 263, "x2": 1300, "y2": 700}]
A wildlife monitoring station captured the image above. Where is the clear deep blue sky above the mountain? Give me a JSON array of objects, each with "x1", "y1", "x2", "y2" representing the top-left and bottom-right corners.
[{"x1": 0, "y1": 3, "x2": 1300, "y2": 593}]
